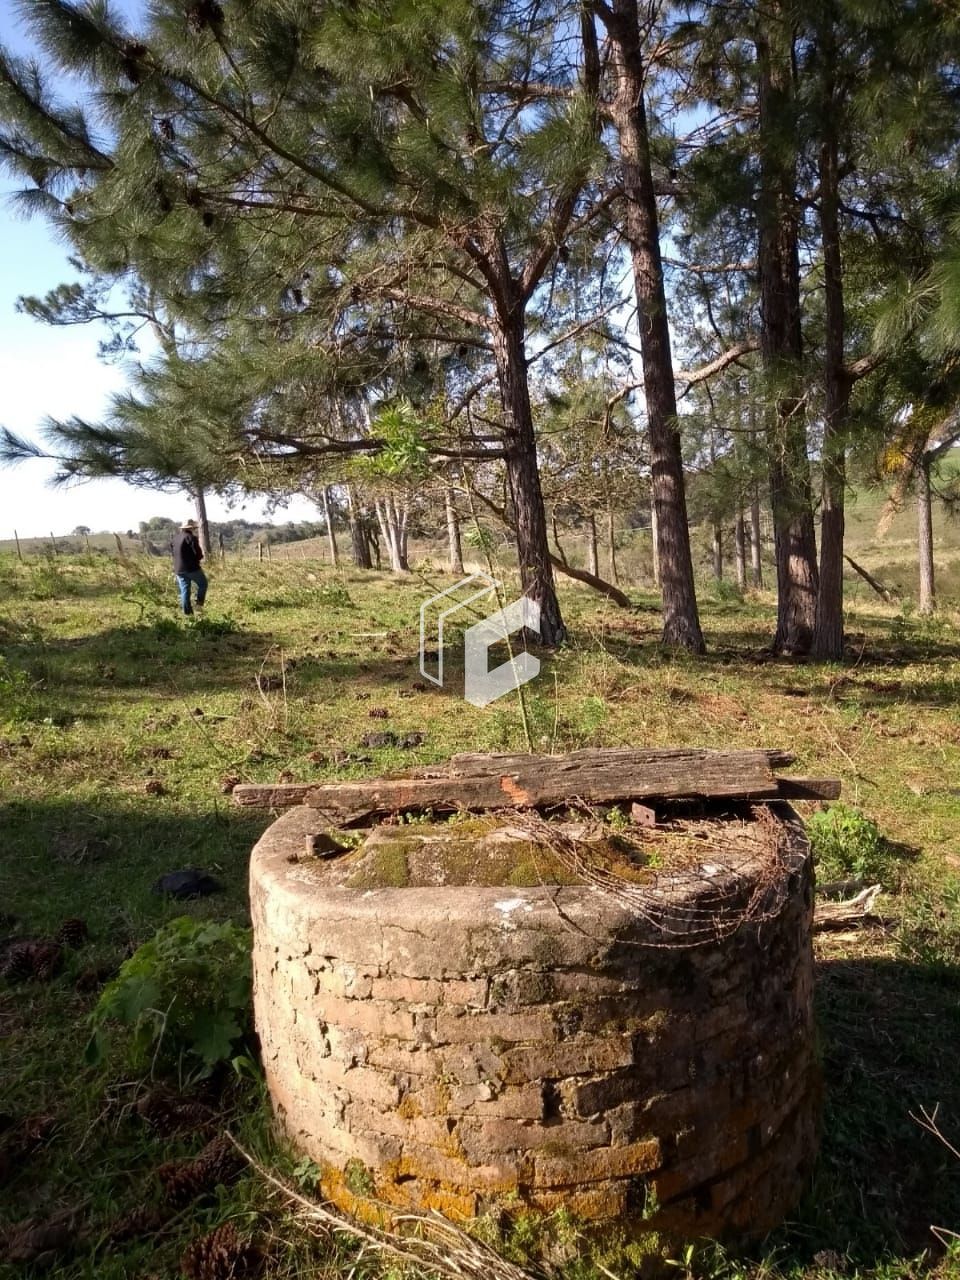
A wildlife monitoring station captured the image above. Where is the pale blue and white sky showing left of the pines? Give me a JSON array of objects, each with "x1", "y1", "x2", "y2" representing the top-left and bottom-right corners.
[{"x1": 0, "y1": 0, "x2": 317, "y2": 541}]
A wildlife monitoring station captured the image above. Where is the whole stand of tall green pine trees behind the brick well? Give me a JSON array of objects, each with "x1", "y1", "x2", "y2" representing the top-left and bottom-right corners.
[{"x1": 0, "y1": 0, "x2": 960, "y2": 659}]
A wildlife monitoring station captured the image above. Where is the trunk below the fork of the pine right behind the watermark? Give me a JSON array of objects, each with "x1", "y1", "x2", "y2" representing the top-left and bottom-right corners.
[{"x1": 492, "y1": 305, "x2": 567, "y2": 645}]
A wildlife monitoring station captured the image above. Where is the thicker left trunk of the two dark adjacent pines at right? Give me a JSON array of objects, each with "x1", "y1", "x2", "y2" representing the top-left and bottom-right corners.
[{"x1": 756, "y1": 18, "x2": 818, "y2": 654}]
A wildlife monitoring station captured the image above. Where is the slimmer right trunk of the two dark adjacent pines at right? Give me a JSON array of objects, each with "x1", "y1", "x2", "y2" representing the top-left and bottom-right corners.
[{"x1": 813, "y1": 6, "x2": 851, "y2": 660}]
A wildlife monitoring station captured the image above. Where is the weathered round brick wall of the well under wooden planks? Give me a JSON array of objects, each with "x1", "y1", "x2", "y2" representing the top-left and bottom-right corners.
[{"x1": 251, "y1": 806, "x2": 818, "y2": 1236}]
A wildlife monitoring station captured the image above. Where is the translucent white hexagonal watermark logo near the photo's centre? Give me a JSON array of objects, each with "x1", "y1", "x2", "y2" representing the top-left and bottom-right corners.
[{"x1": 420, "y1": 573, "x2": 540, "y2": 707}]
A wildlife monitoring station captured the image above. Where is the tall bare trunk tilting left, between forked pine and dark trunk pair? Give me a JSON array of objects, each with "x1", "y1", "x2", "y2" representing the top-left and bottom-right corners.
[{"x1": 599, "y1": 0, "x2": 705, "y2": 653}]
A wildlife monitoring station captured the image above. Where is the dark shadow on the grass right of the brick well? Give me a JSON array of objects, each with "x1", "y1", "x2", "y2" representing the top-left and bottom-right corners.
[{"x1": 767, "y1": 957, "x2": 960, "y2": 1266}]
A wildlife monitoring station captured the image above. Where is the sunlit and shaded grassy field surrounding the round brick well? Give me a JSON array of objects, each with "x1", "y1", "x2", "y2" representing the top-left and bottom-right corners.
[{"x1": 0, "y1": 556, "x2": 960, "y2": 1280}]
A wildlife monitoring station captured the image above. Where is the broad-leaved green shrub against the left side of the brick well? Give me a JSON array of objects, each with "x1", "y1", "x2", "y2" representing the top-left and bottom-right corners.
[{"x1": 87, "y1": 916, "x2": 252, "y2": 1079}]
